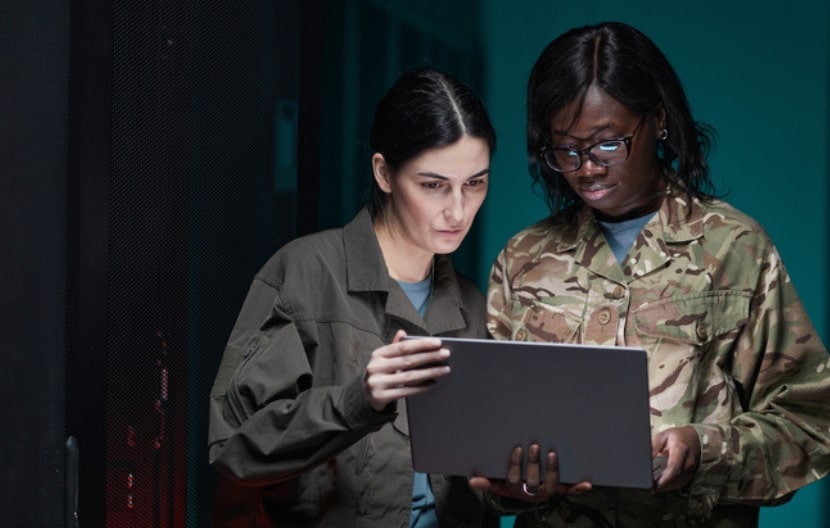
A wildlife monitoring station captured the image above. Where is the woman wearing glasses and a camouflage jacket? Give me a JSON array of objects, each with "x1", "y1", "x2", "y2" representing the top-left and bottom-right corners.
[{"x1": 471, "y1": 23, "x2": 830, "y2": 527}]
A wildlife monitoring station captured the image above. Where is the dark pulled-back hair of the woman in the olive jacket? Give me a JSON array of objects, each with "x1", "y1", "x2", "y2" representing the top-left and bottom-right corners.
[{"x1": 367, "y1": 68, "x2": 496, "y2": 218}]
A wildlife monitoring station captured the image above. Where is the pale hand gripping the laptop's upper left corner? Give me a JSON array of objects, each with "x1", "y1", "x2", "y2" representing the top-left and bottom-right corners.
[{"x1": 363, "y1": 330, "x2": 450, "y2": 411}]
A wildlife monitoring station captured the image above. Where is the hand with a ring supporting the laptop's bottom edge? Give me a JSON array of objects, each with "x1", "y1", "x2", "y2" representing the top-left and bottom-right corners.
[{"x1": 469, "y1": 444, "x2": 591, "y2": 502}]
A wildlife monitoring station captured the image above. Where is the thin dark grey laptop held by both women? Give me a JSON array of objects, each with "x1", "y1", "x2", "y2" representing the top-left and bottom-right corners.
[{"x1": 406, "y1": 336, "x2": 653, "y2": 489}]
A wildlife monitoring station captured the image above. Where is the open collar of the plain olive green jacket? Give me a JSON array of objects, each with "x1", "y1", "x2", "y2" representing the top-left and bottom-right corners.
[{"x1": 343, "y1": 208, "x2": 467, "y2": 334}]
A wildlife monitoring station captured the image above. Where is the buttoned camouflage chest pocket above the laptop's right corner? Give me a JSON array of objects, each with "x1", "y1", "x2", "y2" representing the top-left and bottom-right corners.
[{"x1": 631, "y1": 291, "x2": 752, "y2": 347}]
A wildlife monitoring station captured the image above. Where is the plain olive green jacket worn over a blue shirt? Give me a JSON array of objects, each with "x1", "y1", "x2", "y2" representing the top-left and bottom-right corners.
[{"x1": 209, "y1": 210, "x2": 486, "y2": 528}]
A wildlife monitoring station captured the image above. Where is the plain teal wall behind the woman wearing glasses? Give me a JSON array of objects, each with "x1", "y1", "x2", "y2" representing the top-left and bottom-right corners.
[{"x1": 477, "y1": 0, "x2": 830, "y2": 528}]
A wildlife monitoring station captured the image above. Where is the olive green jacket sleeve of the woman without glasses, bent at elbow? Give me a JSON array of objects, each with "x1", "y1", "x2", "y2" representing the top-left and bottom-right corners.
[{"x1": 208, "y1": 279, "x2": 394, "y2": 485}]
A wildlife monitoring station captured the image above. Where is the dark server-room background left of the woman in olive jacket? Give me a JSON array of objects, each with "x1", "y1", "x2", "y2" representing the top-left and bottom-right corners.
[{"x1": 0, "y1": 0, "x2": 481, "y2": 527}]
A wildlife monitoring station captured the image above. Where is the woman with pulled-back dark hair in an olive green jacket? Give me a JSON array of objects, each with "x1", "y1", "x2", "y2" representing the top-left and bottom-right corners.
[{"x1": 209, "y1": 69, "x2": 496, "y2": 527}]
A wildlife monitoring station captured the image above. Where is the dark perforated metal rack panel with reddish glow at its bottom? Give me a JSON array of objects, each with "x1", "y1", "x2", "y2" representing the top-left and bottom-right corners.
[{"x1": 106, "y1": 1, "x2": 299, "y2": 527}]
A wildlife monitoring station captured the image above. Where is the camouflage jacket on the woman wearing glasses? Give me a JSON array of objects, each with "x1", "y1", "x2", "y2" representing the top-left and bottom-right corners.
[{"x1": 488, "y1": 192, "x2": 830, "y2": 527}]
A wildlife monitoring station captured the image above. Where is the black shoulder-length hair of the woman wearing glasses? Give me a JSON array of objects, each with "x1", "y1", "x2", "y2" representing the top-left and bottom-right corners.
[{"x1": 527, "y1": 22, "x2": 714, "y2": 221}]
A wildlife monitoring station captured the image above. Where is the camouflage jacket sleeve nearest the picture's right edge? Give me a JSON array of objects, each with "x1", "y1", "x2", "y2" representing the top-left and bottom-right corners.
[{"x1": 689, "y1": 244, "x2": 830, "y2": 509}]
